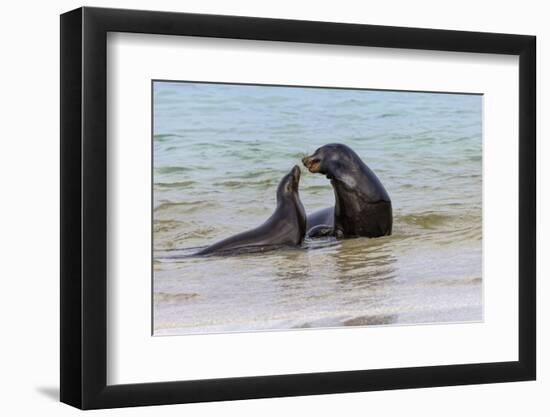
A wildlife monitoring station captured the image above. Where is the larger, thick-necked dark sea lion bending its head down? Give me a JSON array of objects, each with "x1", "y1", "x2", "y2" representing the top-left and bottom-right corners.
[{"x1": 302, "y1": 143, "x2": 393, "y2": 238}]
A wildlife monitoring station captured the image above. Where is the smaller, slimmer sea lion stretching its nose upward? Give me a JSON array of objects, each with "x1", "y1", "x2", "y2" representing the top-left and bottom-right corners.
[{"x1": 197, "y1": 165, "x2": 306, "y2": 255}]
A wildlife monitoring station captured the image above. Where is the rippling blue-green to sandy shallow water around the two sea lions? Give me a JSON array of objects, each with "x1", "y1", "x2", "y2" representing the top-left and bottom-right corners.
[{"x1": 153, "y1": 82, "x2": 483, "y2": 335}]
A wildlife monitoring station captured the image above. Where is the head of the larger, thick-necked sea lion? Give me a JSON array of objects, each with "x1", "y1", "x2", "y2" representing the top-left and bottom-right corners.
[{"x1": 302, "y1": 143, "x2": 360, "y2": 182}]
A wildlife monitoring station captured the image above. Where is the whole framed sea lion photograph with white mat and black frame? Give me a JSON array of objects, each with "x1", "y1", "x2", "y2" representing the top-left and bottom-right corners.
[{"x1": 60, "y1": 7, "x2": 536, "y2": 409}]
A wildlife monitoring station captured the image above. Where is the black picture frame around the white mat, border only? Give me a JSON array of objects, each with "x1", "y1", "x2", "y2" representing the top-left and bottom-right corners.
[{"x1": 60, "y1": 7, "x2": 536, "y2": 409}]
